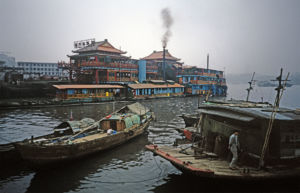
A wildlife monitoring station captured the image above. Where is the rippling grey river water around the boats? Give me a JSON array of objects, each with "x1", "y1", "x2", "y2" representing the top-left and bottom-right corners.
[{"x1": 0, "y1": 85, "x2": 300, "y2": 193}]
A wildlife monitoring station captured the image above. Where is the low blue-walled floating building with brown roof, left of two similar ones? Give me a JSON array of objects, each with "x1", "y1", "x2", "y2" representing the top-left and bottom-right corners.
[{"x1": 53, "y1": 84, "x2": 124, "y2": 103}]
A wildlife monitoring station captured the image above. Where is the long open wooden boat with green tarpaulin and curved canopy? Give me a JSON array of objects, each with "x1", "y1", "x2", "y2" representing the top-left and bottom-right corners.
[{"x1": 14, "y1": 103, "x2": 153, "y2": 165}]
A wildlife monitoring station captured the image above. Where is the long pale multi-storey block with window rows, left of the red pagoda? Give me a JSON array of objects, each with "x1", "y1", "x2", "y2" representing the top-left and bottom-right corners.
[{"x1": 18, "y1": 62, "x2": 68, "y2": 79}]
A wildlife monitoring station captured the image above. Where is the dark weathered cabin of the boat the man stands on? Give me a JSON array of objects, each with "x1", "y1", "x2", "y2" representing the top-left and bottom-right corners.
[{"x1": 199, "y1": 102, "x2": 300, "y2": 165}]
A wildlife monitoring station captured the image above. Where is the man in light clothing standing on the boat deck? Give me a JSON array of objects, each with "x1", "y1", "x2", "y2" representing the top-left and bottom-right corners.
[{"x1": 228, "y1": 131, "x2": 240, "y2": 169}]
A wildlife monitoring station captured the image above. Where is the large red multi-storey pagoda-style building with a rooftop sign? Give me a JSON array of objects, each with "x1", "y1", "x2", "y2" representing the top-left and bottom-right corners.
[{"x1": 69, "y1": 39, "x2": 138, "y2": 84}]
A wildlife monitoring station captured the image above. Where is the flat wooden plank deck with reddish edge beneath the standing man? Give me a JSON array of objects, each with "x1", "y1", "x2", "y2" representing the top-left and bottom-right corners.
[{"x1": 146, "y1": 145, "x2": 300, "y2": 179}]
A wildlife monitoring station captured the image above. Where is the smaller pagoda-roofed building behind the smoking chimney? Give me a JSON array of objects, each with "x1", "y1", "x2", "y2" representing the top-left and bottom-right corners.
[{"x1": 142, "y1": 50, "x2": 183, "y2": 80}]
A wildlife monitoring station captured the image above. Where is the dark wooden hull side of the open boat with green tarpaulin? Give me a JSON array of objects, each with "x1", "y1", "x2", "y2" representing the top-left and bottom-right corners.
[{"x1": 15, "y1": 120, "x2": 151, "y2": 165}]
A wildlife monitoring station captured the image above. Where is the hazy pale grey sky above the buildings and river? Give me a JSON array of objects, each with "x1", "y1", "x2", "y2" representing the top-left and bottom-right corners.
[{"x1": 0, "y1": 0, "x2": 300, "y2": 74}]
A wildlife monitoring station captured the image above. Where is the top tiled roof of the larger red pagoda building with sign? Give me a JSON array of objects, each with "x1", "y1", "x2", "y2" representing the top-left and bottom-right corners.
[{"x1": 73, "y1": 39, "x2": 126, "y2": 54}]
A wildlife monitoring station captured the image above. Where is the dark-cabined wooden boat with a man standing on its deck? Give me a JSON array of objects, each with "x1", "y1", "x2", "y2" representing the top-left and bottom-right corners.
[{"x1": 146, "y1": 101, "x2": 300, "y2": 180}]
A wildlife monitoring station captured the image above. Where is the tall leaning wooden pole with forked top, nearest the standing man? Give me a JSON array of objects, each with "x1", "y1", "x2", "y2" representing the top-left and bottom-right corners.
[{"x1": 259, "y1": 68, "x2": 290, "y2": 168}]
